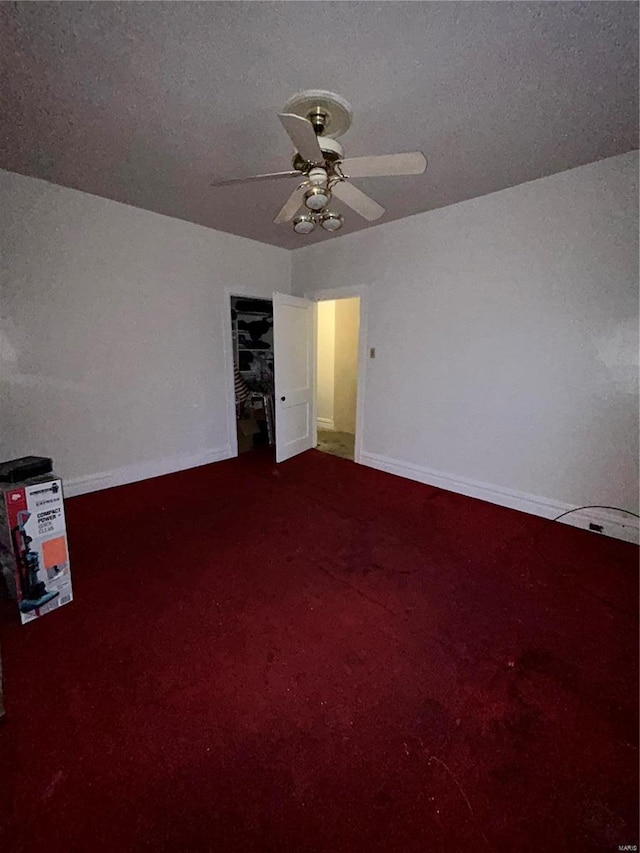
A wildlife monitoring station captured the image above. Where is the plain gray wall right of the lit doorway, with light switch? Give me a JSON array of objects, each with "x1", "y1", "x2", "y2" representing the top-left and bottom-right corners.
[{"x1": 292, "y1": 152, "x2": 638, "y2": 514}]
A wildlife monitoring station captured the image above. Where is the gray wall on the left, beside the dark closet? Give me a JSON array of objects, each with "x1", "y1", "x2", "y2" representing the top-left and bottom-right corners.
[{"x1": 0, "y1": 172, "x2": 291, "y2": 493}]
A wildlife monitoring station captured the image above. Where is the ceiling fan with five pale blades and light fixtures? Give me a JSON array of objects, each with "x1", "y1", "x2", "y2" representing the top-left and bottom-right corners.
[{"x1": 211, "y1": 89, "x2": 427, "y2": 234}]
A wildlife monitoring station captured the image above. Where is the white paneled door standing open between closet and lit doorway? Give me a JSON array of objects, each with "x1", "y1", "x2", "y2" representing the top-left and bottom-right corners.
[{"x1": 273, "y1": 293, "x2": 316, "y2": 462}]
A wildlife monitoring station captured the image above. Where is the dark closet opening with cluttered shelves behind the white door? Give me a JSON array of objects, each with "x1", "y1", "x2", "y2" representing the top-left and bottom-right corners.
[{"x1": 231, "y1": 296, "x2": 275, "y2": 456}]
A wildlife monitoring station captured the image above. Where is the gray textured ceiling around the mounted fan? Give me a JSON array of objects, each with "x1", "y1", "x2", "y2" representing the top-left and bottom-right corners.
[{"x1": 0, "y1": 2, "x2": 638, "y2": 249}]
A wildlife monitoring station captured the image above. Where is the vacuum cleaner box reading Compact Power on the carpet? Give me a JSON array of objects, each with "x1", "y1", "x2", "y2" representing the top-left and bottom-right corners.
[{"x1": 0, "y1": 476, "x2": 73, "y2": 625}]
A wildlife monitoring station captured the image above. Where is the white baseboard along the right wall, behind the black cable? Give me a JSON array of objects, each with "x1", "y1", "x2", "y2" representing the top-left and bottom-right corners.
[{"x1": 360, "y1": 451, "x2": 639, "y2": 544}]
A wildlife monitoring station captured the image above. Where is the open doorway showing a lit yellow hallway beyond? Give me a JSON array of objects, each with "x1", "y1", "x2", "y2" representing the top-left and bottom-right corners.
[{"x1": 316, "y1": 296, "x2": 360, "y2": 460}]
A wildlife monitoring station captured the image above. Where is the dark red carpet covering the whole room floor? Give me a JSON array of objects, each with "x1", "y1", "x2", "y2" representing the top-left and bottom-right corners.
[{"x1": 0, "y1": 451, "x2": 638, "y2": 853}]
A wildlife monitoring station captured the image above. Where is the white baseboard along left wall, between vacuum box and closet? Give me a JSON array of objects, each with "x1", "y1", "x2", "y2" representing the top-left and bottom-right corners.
[{"x1": 63, "y1": 445, "x2": 232, "y2": 498}]
